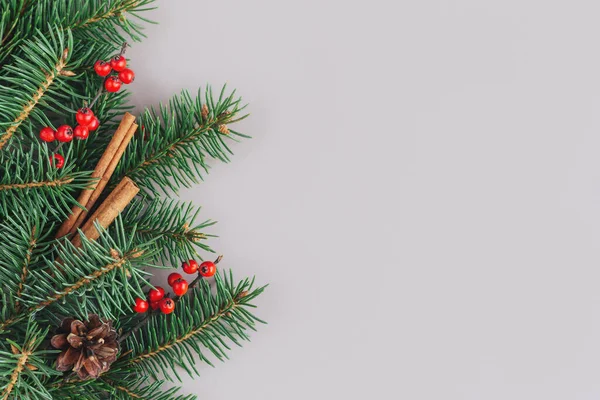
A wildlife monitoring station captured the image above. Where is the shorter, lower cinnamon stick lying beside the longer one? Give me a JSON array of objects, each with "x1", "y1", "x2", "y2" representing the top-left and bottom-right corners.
[{"x1": 72, "y1": 177, "x2": 140, "y2": 247}]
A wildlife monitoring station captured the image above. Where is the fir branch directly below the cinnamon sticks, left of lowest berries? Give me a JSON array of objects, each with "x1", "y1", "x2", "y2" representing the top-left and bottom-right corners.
[{"x1": 0, "y1": 219, "x2": 155, "y2": 332}]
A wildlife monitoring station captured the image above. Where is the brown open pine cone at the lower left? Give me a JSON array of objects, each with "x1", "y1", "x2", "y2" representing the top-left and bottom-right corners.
[{"x1": 50, "y1": 314, "x2": 119, "y2": 379}]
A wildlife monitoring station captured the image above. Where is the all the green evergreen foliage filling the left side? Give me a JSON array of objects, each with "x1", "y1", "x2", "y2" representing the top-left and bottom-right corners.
[{"x1": 0, "y1": 0, "x2": 264, "y2": 400}]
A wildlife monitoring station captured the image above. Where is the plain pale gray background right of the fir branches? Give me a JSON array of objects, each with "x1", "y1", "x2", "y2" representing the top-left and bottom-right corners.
[{"x1": 129, "y1": 0, "x2": 600, "y2": 400}]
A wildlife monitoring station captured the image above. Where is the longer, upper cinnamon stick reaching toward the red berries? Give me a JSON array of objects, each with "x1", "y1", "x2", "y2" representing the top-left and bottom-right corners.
[{"x1": 56, "y1": 112, "x2": 135, "y2": 238}]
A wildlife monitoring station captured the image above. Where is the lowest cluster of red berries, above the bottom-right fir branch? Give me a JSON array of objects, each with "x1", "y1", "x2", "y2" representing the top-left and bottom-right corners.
[{"x1": 133, "y1": 260, "x2": 217, "y2": 314}]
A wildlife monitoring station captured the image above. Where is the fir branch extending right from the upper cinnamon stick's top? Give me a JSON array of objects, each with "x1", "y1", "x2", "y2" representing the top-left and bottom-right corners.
[{"x1": 111, "y1": 87, "x2": 247, "y2": 194}]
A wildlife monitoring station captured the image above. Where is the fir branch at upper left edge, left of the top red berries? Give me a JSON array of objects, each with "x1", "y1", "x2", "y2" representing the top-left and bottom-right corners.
[{"x1": 0, "y1": 23, "x2": 136, "y2": 149}]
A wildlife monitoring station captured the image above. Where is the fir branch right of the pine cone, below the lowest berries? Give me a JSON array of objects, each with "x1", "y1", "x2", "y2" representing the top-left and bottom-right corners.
[{"x1": 119, "y1": 273, "x2": 265, "y2": 380}]
